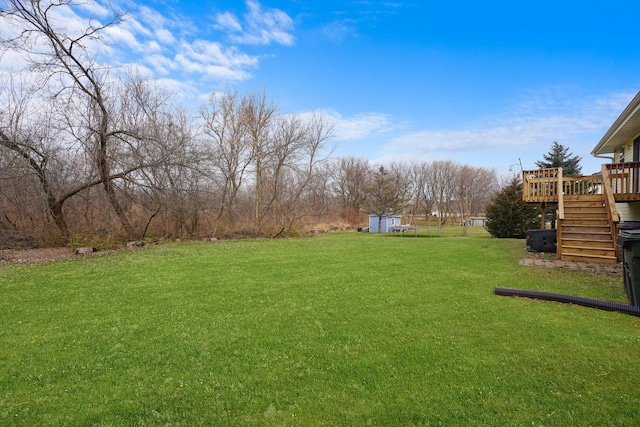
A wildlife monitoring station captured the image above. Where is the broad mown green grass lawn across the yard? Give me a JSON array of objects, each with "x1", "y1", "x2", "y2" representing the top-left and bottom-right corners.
[{"x1": 0, "y1": 228, "x2": 640, "y2": 426}]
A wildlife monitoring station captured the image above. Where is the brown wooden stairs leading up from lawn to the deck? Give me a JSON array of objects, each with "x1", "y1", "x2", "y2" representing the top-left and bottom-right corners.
[{"x1": 557, "y1": 194, "x2": 618, "y2": 264}]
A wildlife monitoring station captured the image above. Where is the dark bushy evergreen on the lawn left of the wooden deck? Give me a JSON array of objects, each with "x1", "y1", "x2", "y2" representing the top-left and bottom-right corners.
[{"x1": 485, "y1": 178, "x2": 540, "y2": 239}]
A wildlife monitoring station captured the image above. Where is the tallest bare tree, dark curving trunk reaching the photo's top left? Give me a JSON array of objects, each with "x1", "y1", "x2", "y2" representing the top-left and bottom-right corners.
[{"x1": 0, "y1": 0, "x2": 140, "y2": 238}]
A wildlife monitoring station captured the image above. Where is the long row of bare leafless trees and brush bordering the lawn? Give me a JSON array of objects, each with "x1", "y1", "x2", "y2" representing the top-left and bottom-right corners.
[{"x1": 0, "y1": 0, "x2": 498, "y2": 243}]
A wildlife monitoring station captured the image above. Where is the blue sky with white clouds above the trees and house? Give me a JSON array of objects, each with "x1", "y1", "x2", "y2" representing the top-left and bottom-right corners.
[{"x1": 6, "y1": 0, "x2": 640, "y2": 173}]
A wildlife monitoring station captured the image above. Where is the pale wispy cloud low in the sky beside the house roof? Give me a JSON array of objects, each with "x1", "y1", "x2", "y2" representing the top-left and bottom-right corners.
[{"x1": 379, "y1": 93, "x2": 634, "y2": 167}]
